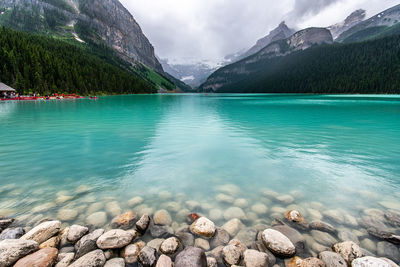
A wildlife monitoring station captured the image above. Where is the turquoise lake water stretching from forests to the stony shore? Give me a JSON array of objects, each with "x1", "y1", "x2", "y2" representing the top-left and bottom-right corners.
[{"x1": 0, "y1": 95, "x2": 400, "y2": 233}]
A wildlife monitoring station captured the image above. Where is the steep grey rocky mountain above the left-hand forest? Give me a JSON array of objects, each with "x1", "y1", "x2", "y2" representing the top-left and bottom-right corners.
[{"x1": 0, "y1": 0, "x2": 163, "y2": 72}]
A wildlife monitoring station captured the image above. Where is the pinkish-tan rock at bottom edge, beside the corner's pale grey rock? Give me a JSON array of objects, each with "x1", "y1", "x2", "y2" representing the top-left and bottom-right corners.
[{"x1": 14, "y1": 248, "x2": 58, "y2": 267}]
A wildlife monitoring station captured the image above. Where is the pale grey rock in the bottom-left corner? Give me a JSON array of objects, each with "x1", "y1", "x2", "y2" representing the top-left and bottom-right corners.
[{"x1": 0, "y1": 239, "x2": 39, "y2": 266}]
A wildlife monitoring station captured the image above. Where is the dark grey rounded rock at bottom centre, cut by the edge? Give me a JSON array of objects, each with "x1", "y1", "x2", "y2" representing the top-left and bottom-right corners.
[{"x1": 174, "y1": 247, "x2": 207, "y2": 267}]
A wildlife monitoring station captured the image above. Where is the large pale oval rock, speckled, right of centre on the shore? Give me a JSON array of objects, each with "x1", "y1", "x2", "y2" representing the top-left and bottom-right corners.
[{"x1": 262, "y1": 229, "x2": 296, "y2": 257}]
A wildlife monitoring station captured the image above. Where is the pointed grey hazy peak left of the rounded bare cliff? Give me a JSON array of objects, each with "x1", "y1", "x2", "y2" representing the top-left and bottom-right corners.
[{"x1": 238, "y1": 21, "x2": 295, "y2": 59}]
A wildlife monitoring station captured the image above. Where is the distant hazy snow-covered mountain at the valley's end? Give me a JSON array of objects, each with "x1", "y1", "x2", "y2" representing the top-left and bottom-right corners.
[{"x1": 160, "y1": 59, "x2": 218, "y2": 88}]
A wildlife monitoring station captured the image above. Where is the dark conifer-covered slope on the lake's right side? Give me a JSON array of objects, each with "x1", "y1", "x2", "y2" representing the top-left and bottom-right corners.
[{"x1": 201, "y1": 36, "x2": 400, "y2": 94}]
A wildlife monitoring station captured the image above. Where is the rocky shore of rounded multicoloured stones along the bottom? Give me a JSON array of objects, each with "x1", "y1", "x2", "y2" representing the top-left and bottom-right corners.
[{"x1": 0, "y1": 200, "x2": 400, "y2": 267}]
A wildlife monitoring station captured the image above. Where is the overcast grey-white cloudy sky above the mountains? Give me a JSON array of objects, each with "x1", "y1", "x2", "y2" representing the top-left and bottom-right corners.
[{"x1": 120, "y1": 0, "x2": 400, "y2": 63}]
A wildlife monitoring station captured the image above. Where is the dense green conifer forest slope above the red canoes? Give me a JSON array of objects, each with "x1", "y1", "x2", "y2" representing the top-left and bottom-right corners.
[{"x1": 0, "y1": 27, "x2": 157, "y2": 95}]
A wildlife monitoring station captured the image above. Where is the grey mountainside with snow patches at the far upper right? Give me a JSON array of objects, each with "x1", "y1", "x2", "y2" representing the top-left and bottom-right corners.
[{"x1": 337, "y1": 5, "x2": 400, "y2": 43}]
